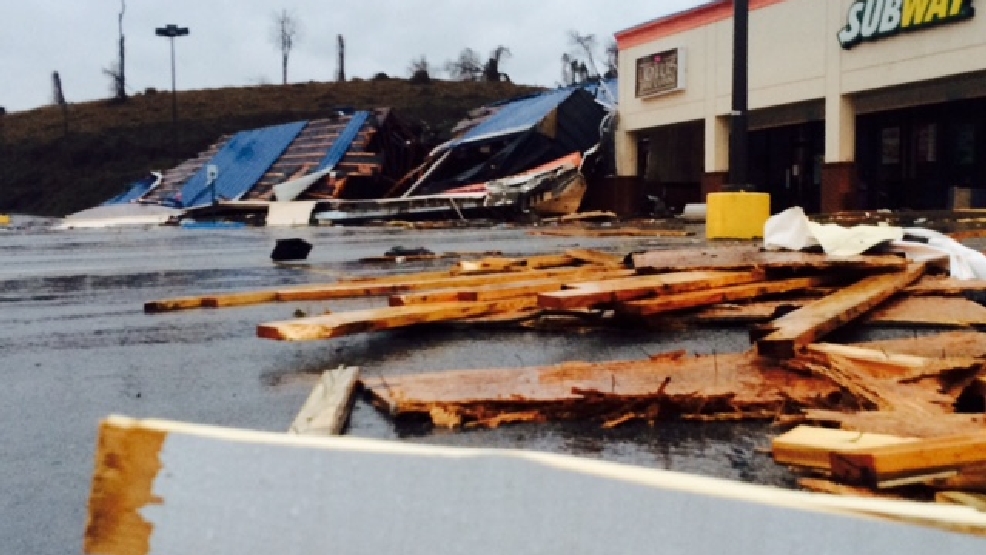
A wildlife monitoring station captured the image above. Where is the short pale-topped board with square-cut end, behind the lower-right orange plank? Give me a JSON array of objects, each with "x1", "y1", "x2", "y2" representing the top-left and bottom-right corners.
[{"x1": 771, "y1": 426, "x2": 917, "y2": 472}]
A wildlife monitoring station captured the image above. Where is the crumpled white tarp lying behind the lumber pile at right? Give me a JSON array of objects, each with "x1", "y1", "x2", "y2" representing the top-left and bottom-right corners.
[{"x1": 764, "y1": 207, "x2": 986, "y2": 279}]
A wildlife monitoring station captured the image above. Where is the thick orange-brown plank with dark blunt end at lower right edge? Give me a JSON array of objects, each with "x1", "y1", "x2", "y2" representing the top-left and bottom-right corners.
[{"x1": 830, "y1": 431, "x2": 986, "y2": 486}]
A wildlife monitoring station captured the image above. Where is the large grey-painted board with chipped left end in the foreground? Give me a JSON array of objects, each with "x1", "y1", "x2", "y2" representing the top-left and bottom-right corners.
[{"x1": 84, "y1": 417, "x2": 986, "y2": 555}]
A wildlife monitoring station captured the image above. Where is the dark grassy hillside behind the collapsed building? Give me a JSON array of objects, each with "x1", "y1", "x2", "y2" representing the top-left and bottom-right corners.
[{"x1": 0, "y1": 79, "x2": 536, "y2": 216}]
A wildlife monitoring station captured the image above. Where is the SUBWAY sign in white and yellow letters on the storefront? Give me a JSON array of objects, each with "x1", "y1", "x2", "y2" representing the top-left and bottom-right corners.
[{"x1": 839, "y1": 0, "x2": 976, "y2": 49}]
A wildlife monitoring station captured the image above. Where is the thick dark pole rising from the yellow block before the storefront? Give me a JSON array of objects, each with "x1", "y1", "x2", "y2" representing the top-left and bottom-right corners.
[{"x1": 729, "y1": 0, "x2": 750, "y2": 189}]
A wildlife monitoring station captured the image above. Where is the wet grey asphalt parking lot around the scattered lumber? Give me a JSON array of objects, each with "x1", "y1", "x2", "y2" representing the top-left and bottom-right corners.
[{"x1": 0, "y1": 221, "x2": 816, "y2": 554}]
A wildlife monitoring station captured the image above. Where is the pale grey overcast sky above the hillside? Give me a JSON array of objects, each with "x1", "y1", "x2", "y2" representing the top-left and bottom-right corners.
[{"x1": 0, "y1": 0, "x2": 704, "y2": 112}]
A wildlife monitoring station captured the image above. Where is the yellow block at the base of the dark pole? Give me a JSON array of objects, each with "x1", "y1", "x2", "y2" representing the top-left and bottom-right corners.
[{"x1": 705, "y1": 191, "x2": 770, "y2": 239}]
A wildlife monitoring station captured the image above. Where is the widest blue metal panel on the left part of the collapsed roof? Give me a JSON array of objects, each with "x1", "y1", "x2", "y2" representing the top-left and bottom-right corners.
[{"x1": 181, "y1": 121, "x2": 308, "y2": 207}]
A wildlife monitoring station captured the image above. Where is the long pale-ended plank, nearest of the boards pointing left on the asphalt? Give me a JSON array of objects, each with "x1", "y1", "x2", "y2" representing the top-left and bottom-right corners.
[{"x1": 257, "y1": 297, "x2": 537, "y2": 341}]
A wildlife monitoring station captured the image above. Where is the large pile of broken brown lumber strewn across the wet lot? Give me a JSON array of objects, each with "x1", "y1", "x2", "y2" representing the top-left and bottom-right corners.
[{"x1": 145, "y1": 246, "x2": 986, "y2": 437}]
